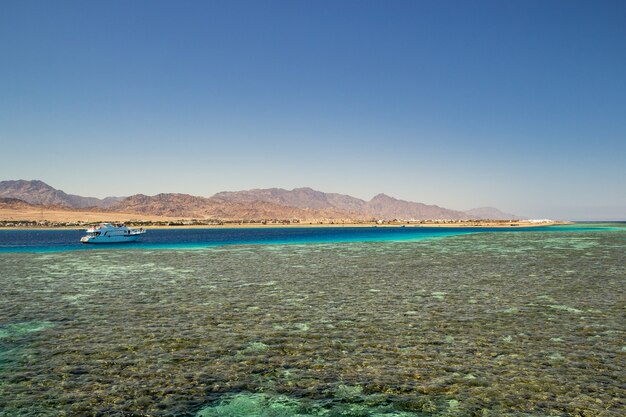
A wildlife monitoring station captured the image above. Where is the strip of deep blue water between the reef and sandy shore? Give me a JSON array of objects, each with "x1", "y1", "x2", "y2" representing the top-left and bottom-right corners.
[{"x1": 0, "y1": 225, "x2": 608, "y2": 252}]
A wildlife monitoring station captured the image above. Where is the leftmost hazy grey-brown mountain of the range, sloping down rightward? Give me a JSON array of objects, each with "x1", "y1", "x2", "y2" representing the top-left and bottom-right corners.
[{"x1": 0, "y1": 180, "x2": 121, "y2": 208}]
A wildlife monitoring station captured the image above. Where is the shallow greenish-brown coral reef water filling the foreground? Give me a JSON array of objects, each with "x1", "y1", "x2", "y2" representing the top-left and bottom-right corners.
[{"x1": 0, "y1": 225, "x2": 626, "y2": 417}]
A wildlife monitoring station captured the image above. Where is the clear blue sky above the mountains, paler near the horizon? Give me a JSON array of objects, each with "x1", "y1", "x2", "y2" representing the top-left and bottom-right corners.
[{"x1": 0, "y1": 0, "x2": 626, "y2": 219}]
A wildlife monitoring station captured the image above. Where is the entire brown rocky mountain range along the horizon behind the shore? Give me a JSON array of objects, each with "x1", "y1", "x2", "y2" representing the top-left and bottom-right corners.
[{"x1": 0, "y1": 180, "x2": 520, "y2": 220}]
